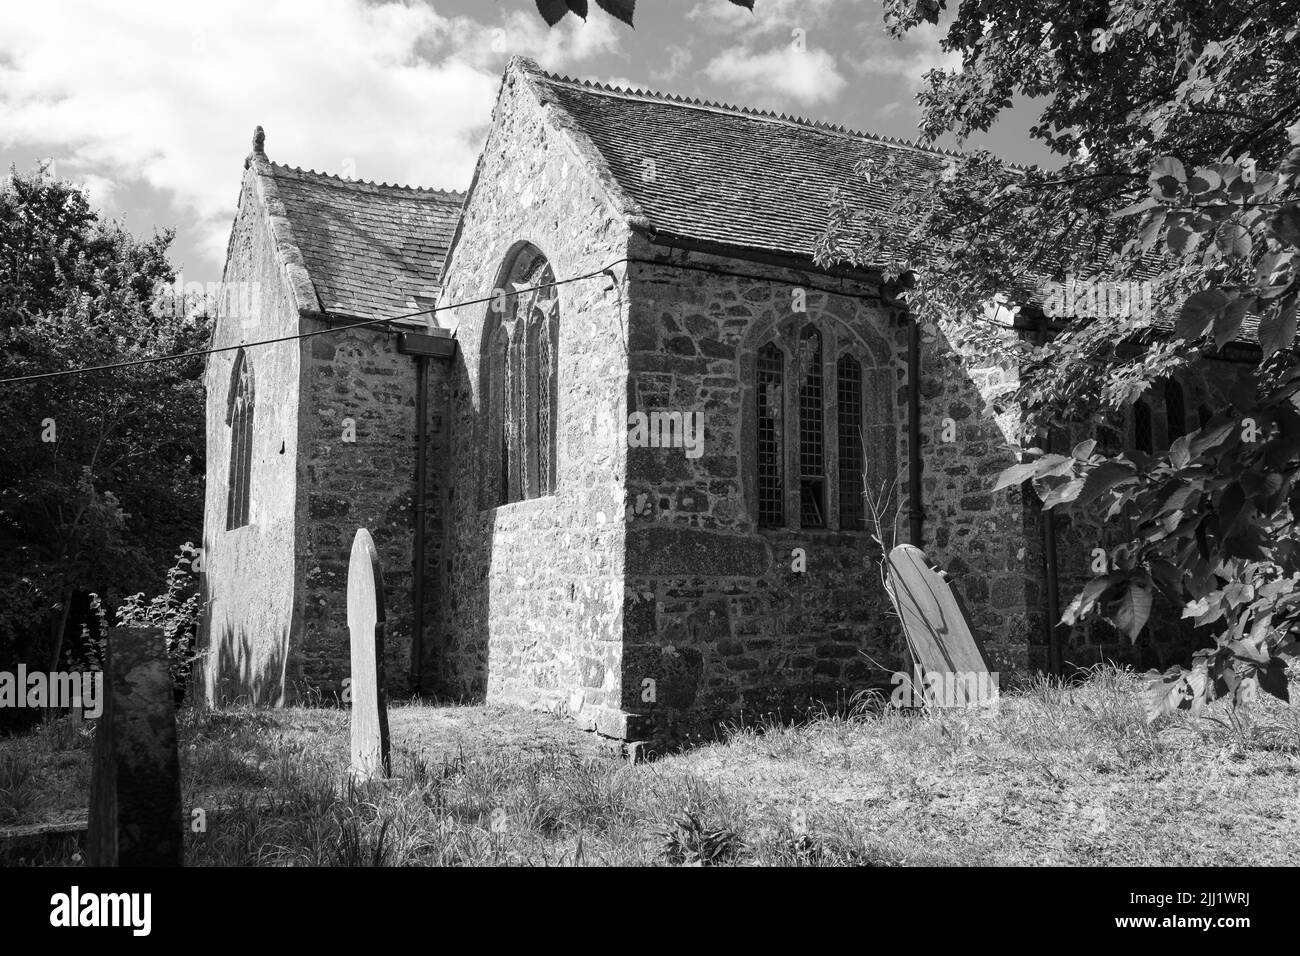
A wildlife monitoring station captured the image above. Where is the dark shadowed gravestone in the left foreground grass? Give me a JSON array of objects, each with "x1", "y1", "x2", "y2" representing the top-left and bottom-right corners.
[{"x1": 86, "y1": 627, "x2": 185, "y2": 866}]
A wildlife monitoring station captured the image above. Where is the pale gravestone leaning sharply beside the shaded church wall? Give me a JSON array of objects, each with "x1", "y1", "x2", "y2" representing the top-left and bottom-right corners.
[{"x1": 888, "y1": 545, "x2": 989, "y2": 702}]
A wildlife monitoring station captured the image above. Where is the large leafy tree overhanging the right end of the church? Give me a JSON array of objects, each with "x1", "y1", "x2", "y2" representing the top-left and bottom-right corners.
[{"x1": 819, "y1": 0, "x2": 1300, "y2": 714}]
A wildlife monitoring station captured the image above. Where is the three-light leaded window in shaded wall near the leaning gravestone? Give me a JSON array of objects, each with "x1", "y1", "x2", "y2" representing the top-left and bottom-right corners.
[{"x1": 753, "y1": 323, "x2": 897, "y2": 531}]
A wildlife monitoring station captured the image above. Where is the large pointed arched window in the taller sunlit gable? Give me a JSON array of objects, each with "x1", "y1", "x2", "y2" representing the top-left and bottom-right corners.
[{"x1": 480, "y1": 243, "x2": 559, "y2": 507}]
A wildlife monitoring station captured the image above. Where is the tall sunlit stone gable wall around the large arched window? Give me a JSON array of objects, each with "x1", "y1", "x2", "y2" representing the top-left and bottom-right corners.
[{"x1": 439, "y1": 72, "x2": 627, "y2": 737}]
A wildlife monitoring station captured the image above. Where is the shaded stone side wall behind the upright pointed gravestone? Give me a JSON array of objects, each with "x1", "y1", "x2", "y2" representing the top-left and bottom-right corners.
[{"x1": 287, "y1": 325, "x2": 450, "y2": 697}]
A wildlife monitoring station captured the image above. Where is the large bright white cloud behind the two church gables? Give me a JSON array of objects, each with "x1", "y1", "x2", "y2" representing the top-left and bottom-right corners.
[{"x1": 0, "y1": 0, "x2": 619, "y2": 264}]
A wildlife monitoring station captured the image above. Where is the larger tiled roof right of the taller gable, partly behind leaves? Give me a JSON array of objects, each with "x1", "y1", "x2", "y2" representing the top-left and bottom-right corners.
[{"x1": 512, "y1": 57, "x2": 958, "y2": 264}]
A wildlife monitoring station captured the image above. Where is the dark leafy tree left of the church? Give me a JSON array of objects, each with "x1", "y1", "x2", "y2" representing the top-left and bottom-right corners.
[{"x1": 0, "y1": 169, "x2": 208, "y2": 712}]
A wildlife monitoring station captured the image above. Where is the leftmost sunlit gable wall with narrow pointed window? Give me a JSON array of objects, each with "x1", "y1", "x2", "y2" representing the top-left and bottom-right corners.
[{"x1": 200, "y1": 169, "x2": 300, "y2": 705}]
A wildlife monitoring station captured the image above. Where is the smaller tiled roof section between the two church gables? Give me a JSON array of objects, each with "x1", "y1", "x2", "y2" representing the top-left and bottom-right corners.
[{"x1": 264, "y1": 163, "x2": 464, "y2": 319}]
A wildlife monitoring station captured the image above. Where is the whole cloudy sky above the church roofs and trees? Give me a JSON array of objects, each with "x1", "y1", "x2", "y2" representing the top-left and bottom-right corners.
[{"x1": 0, "y1": 0, "x2": 1045, "y2": 281}]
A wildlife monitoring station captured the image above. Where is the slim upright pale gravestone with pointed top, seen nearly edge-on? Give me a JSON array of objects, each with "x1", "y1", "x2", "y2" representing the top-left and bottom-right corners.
[{"x1": 347, "y1": 528, "x2": 391, "y2": 780}]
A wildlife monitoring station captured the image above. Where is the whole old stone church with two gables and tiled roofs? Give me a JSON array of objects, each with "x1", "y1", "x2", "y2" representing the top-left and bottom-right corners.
[{"x1": 203, "y1": 59, "x2": 1242, "y2": 740}]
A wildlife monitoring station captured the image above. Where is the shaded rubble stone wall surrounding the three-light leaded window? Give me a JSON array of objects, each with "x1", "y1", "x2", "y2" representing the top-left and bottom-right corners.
[{"x1": 621, "y1": 239, "x2": 906, "y2": 737}]
